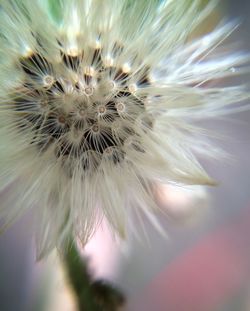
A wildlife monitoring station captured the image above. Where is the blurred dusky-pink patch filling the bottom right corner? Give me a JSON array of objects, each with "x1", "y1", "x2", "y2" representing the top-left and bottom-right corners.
[{"x1": 129, "y1": 208, "x2": 250, "y2": 311}]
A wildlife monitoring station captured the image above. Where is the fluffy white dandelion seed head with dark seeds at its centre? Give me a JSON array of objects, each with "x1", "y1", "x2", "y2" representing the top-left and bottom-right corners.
[{"x1": 0, "y1": 0, "x2": 249, "y2": 256}]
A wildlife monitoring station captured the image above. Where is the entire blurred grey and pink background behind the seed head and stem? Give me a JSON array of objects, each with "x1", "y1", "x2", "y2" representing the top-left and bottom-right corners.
[{"x1": 0, "y1": 0, "x2": 250, "y2": 311}]
